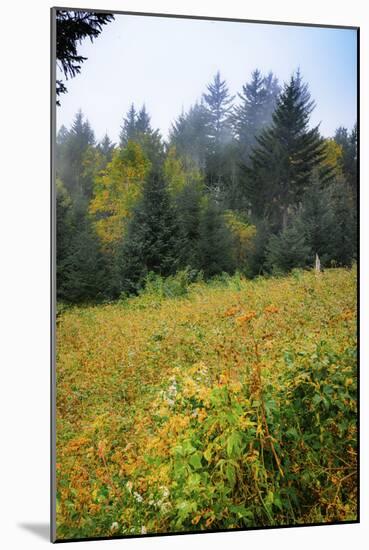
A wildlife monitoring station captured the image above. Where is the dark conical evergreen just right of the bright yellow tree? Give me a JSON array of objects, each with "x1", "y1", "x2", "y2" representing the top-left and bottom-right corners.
[{"x1": 120, "y1": 171, "x2": 180, "y2": 293}]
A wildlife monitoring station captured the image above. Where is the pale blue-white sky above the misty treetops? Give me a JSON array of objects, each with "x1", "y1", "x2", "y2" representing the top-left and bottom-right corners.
[{"x1": 57, "y1": 15, "x2": 357, "y2": 142}]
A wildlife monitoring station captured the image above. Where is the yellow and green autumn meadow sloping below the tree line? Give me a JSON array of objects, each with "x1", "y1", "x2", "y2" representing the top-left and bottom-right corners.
[{"x1": 56, "y1": 267, "x2": 357, "y2": 539}]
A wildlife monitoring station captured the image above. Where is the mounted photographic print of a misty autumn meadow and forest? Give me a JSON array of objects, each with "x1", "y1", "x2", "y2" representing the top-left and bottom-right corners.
[{"x1": 51, "y1": 8, "x2": 359, "y2": 541}]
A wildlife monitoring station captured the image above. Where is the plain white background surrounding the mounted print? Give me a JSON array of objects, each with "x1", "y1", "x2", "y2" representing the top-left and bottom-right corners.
[{"x1": 0, "y1": 0, "x2": 369, "y2": 550}]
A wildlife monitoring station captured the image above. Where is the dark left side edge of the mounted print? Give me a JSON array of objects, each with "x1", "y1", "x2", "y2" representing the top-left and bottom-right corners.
[{"x1": 50, "y1": 4, "x2": 57, "y2": 542}]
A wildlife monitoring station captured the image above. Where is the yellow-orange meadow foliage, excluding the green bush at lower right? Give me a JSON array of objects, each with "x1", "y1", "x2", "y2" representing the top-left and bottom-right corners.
[{"x1": 56, "y1": 269, "x2": 356, "y2": 538}]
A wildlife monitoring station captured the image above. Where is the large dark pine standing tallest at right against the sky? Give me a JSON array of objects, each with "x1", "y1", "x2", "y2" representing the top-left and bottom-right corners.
[{"x1": 246, "y1": 72, "x2": 331, "y2": 231}]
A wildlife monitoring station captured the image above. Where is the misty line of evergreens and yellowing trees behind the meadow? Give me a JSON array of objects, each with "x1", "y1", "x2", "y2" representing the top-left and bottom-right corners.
[{"x1": 56, "y1": 70, "x2": 357, "y2": 303}]
